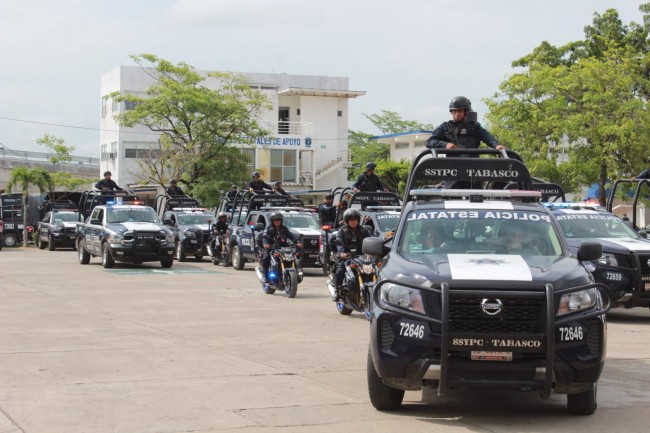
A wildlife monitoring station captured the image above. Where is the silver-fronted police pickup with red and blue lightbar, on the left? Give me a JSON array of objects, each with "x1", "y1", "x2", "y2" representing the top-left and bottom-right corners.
[{"x1": 77, "y1": 201, "x2": 175, "y2": 268}]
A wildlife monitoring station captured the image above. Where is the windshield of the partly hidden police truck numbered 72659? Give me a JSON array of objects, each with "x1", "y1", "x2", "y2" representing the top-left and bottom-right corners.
[{"x1": 555, "y1": 212, "x2": 639, "y2": 239}]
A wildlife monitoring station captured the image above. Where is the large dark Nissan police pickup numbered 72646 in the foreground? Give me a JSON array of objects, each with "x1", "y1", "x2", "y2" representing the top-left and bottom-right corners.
[{"x1": 363, "y1": 149, "x2": 609, "y2": 414}]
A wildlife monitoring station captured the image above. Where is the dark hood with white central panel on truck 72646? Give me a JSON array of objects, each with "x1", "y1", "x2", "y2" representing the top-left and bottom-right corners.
[{"x1": 381, "y1": 253, "x2": 593, "y2": 290}]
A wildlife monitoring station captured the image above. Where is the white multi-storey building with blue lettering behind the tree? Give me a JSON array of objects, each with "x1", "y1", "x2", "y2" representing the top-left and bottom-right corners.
[{"x1": 100, "y1": 66, "x2": 365, "y2": 190}]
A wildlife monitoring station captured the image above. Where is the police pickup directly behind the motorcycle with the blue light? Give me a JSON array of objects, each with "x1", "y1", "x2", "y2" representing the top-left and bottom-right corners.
[{"x1": 226, "y1": 193, "x2": 322, "y2": 270}]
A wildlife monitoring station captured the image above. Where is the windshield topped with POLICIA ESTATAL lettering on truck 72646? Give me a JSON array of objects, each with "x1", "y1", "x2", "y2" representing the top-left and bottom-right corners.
[{"x1": 399, "y1": 209, "x2": 562, "y2": 256}]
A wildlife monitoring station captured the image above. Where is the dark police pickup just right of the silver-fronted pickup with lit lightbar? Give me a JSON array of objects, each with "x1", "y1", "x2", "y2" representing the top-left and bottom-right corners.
[{"x1": 158, "y1": 197, "x2": 210, "y2": 262}]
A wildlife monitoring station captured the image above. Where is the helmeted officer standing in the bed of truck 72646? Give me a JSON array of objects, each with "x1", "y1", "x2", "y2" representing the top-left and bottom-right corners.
[{"x1": 426, "y1": 96, "x2": 506, "y2": 150}]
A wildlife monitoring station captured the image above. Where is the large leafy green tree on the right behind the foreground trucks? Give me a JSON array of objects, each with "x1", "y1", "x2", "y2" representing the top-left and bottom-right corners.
[{"x1": 486, "y1": 6, "x2": 650, "y2": 204}]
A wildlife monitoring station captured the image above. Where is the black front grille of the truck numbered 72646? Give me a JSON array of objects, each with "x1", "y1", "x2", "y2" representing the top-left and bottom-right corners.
[{"x1": 449, "y1": 297, "x2": 545, "y2": 334}]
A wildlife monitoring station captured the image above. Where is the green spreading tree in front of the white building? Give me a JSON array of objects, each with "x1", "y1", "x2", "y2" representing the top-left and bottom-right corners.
[{"x1": 111, "y1": 54, "x2": 272, "y2": 193}]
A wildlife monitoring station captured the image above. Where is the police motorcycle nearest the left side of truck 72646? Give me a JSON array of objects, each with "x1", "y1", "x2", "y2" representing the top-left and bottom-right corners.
[{"x1": 327, "y1": 241, "x2": 377, "y2": 317}]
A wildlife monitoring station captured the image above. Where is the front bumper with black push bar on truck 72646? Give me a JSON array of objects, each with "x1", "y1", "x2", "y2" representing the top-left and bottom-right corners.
[{"x1": 370, "y1": 284, "x2": 609, "y2": 398}]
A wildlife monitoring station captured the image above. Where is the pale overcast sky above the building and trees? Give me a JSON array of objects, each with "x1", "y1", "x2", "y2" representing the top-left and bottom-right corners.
[{"x1": 0, "y1": 0, "x2": 643, "y2": 157}]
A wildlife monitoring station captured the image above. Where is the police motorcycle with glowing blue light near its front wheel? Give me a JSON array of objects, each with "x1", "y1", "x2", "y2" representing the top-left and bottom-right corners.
[{"x1": 255, "y1": 224, "x2": 303, "y2": 298}]
